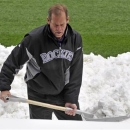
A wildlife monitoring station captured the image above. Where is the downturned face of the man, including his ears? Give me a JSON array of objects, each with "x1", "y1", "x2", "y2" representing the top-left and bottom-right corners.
[{"x1": 47, "y1": 12, "x2": 69, "y2": 39}]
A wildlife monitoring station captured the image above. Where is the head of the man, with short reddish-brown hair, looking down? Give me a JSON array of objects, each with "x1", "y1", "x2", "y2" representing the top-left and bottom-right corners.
[{"x1": 47, "y1": 4, "x2": 69, "y2": 39}]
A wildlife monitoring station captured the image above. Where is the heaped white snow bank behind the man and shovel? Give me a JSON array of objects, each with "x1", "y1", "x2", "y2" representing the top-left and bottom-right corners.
[{"x1": 0, "y1": 45, "x2": 130, "y2": 129}]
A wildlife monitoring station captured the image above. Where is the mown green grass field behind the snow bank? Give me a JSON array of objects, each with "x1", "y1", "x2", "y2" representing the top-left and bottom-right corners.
[{"x1": 0, "y1": 0, "x2": 130, "y2": 57}]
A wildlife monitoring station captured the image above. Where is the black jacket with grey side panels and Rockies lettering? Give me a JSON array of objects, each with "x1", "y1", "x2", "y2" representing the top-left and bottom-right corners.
[{"x1": 0, "y1": 24, "x2": 83, "y2": 103}]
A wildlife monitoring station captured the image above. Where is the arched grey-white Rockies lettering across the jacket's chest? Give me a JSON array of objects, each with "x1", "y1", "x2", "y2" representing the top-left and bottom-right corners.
[{"x1": 40, "y1": 49, "x2": 74, "y2": 64}]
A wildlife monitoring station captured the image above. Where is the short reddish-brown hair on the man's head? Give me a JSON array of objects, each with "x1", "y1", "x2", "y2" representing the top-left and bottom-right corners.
[{"x1": 48, "y1": 4, "x2": 68, "y2": 20}]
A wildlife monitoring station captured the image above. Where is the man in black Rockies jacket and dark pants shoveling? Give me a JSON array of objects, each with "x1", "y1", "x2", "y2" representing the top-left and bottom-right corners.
[{"x1": 0, "y1": 4, "x2": 83, "y2": 120}]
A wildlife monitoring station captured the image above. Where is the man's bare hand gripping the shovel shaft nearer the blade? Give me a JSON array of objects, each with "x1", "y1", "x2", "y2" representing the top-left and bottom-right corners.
[{"x1": 65, "y1": 103, "x2": 77, "y2": 116}]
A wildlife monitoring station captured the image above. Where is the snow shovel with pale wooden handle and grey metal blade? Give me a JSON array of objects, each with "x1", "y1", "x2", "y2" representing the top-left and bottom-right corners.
[{"x1": 6, "y1": 95, "x2": 130, "y2": 122}]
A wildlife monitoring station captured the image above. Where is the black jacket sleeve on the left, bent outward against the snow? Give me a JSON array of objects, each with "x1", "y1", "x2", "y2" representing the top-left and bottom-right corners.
[{"x1": 0, "y1": 36, "x2": 29, "y2": 91}]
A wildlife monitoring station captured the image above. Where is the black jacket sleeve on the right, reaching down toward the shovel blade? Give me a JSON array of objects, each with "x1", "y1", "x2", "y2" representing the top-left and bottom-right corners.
[{"x1": 64, "y1": 34, "x2": 83, "y2": 104}]
